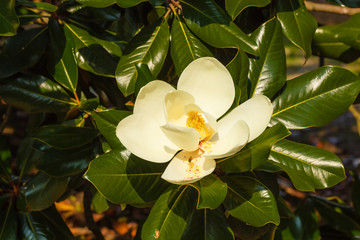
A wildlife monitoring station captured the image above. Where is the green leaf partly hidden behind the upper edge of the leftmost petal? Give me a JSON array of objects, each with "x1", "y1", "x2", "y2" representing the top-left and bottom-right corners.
[{"x1": 92, "y1": 110, "x2": 131, "y2": 150}]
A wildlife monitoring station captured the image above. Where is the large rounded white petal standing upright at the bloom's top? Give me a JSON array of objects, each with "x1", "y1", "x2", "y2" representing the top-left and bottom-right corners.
[{"x1": 177, "y1": 57, "x2": 235, "y2": 119}]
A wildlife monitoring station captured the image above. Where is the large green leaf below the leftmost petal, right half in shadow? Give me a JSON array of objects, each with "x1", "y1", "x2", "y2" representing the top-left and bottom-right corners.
[{"x1": 84, "y1": 150, "x2": 170, "y2": 204}]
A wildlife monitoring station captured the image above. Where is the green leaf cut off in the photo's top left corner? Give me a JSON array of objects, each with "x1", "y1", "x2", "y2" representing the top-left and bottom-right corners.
[{"x1": 0, "y1": 0, "x2": 20, "y2": 36}]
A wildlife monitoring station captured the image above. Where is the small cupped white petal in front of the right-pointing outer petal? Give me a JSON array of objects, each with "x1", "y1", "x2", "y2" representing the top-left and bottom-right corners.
[{"x1": 203, "y1": 121, "x2": 249, "y2": 159}]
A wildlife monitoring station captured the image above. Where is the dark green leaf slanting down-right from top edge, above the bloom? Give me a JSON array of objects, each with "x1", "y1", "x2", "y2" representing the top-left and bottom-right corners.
[{"x1": 179, "y1": 0, "x2": 258, "y2": 55}]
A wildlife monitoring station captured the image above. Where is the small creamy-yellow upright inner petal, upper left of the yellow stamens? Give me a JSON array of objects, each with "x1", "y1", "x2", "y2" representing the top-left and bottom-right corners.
[{"x1": 165, "y1": 90, "x2": 195, "y2": 126}]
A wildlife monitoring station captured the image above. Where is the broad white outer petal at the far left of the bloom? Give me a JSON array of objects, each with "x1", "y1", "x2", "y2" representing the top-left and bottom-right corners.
[{"x1": 116, "y1": 113, "x2": 179, "y2": 163}]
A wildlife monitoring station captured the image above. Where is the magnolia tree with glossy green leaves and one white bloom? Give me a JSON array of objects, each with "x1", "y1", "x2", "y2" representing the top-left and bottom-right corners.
[{"x1": 0, "y1": 0, "x2": 360, "y2": 240}]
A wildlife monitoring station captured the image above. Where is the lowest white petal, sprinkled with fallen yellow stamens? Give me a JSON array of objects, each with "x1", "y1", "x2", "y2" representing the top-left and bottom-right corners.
[{"x1": 161, "y1": 151, "x2": 216, "y2": 184}]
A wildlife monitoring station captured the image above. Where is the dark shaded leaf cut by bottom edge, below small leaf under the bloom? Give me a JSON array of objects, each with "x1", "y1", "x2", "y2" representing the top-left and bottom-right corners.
[{"x1": 181, "y1": 208, "x2": 234, "y2": 240}]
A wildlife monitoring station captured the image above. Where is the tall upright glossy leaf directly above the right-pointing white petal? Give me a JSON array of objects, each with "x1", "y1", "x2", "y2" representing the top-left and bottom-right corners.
[{"x1": 249, "y1": 18, "x2": 286, "y2": 98}]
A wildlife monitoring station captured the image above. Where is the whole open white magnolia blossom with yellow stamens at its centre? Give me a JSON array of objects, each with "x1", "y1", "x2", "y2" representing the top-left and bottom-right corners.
[{"x1": 116, "y1": 57, "x2": 273, "y2": 184}]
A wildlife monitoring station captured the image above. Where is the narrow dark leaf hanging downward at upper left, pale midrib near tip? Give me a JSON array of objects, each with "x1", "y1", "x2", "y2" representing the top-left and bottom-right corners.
[{"x1": 47, "y1": 19, "x2": 78, "y2": 93}]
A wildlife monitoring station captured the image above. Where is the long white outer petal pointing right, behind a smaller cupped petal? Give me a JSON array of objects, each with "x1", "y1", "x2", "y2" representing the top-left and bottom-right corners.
[{"x1": 218, "y1": 95, "x2": 273, "y2": 142}]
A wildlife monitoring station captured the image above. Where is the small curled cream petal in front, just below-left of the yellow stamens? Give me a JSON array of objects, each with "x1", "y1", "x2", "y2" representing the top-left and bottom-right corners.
[{"x1": 161, "y1": 123, "x2": 199, "y2": 151}]
